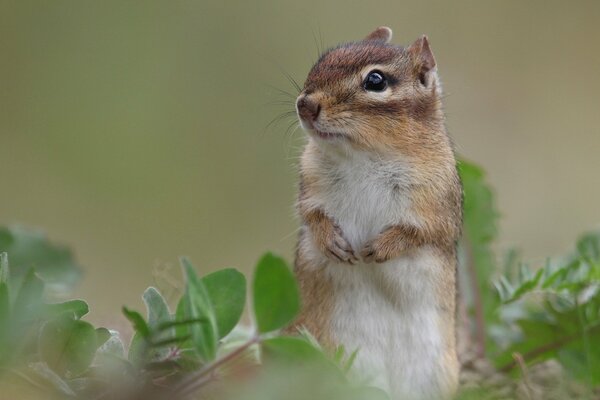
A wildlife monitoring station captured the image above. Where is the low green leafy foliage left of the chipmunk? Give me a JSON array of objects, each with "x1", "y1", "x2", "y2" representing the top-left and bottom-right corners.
[{"x1": 0, "y1": 228, "x2": 386, "y2": 399}]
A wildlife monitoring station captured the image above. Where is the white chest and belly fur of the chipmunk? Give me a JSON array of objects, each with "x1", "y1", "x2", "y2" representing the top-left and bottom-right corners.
[{"x1": 304, "y1": 149, "x2": 445, "y2": 399}]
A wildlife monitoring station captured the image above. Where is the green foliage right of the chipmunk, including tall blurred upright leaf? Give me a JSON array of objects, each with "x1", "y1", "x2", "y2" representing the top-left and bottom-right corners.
[{"x1": 459, "y1": 161, "x2": 600, "y2": 386}]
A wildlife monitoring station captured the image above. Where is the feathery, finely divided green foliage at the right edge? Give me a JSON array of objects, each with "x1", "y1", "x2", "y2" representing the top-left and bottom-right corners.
[{"x1": 496, "y1": 232, "x2": 600, "y2": 385}]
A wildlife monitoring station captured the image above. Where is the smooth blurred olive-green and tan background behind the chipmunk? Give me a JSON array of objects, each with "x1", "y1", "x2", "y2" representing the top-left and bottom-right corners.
[{"x1": 0, "y1": 0, "x2": 600, "y2": 318}]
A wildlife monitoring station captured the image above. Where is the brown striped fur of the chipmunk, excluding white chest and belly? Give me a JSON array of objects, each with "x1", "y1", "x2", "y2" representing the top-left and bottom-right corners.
[{"x1": 294, "y1": 28, "x2": 462, "y2": 398}]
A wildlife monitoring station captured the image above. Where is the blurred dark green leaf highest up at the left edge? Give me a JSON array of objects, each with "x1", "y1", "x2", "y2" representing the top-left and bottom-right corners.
[{"x1": 0, "y1": 226, "x2": 81, "y2": 290}]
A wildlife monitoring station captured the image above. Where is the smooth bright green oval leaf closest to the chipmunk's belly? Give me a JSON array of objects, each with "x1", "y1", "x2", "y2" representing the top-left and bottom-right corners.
[{"x1": 253, "y1": 253, "x2": 300, "y2": 333}]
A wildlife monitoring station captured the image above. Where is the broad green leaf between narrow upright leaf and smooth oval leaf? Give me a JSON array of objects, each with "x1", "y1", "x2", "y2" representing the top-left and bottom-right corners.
[{"x1": 201, "y1": 268, "x2": 246, "y2": 338}]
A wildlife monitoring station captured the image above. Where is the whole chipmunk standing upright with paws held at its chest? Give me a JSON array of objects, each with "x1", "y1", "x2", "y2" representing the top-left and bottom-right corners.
[{"x1": 293, "y1": 27, "x2": 462, "y2": 399}]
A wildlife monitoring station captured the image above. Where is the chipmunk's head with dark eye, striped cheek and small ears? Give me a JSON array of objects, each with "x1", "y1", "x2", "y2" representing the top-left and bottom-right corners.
[{"x1": 296, "y1": 27, "x2": 443, "y2": 150}]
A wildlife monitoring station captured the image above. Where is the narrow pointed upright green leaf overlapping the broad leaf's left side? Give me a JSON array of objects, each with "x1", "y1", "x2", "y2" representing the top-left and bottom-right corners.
[{"x1": 180, "y1": 257, "x2": 219, "y2": 362}]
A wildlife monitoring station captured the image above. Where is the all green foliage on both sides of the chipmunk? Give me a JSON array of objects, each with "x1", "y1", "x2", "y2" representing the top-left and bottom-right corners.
[{"x1": 0, "y1": 161, "x2": 600, "y2": 400}]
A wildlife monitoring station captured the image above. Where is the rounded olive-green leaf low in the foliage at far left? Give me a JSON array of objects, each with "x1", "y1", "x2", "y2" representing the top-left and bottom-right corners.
[{"x1": 39, "y1": 317, "x2": 98, "y2": 376}]
